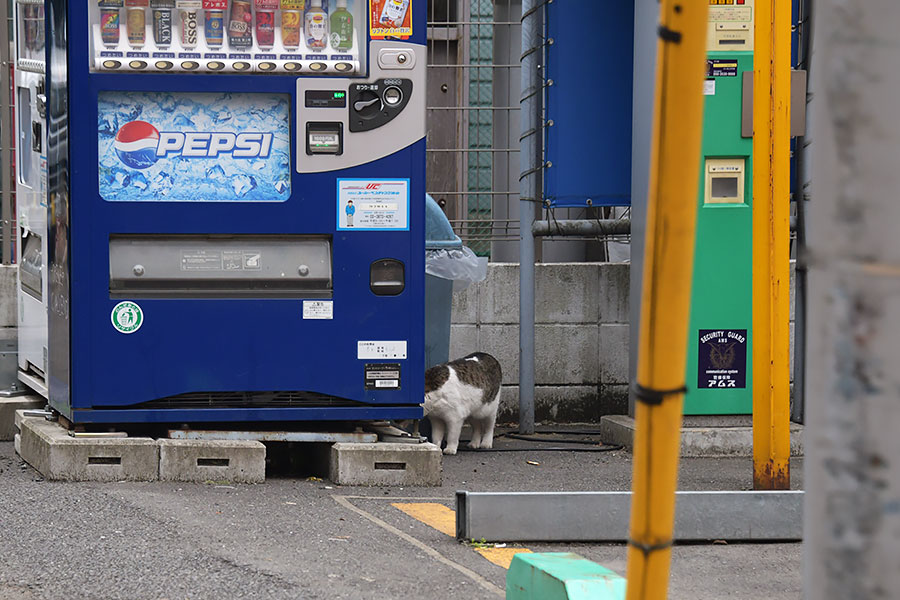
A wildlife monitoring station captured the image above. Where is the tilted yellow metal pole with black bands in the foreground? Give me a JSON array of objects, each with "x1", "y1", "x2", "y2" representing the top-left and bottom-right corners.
[{"x1": 627, "y1": 0, "x2": 708, "y2": 600}]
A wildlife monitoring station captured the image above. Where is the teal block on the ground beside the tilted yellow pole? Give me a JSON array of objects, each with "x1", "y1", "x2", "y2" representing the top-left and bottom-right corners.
[{"x1": 506, "y1": 552, "x2": 625, "y2": 600}]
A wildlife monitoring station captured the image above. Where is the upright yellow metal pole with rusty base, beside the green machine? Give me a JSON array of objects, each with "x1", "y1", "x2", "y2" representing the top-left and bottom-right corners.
[{"x1": 753, "y1": 0, "x2": 791, "y2": 490}]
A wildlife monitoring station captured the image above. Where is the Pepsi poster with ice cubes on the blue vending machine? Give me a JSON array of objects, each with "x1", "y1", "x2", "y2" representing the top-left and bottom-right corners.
[{"x1": 97, "y1": 92, "x2": 291, "y2": 202}]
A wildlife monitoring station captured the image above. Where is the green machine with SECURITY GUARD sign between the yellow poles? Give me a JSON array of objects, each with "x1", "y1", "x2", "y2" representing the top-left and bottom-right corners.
[{"x1": 684, "y1": 0, "x2": 755, "y2": 415}]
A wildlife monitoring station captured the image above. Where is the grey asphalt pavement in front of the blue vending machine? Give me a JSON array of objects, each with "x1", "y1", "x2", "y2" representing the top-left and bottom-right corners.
[{"x1": 0, "y1": 428, "x2": 802, "y2": 600}]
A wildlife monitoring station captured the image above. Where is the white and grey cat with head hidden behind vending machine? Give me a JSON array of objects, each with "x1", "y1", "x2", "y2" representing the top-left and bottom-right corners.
[{"x1": 425, "y1": 352, "x2": 503, "y2": 454}]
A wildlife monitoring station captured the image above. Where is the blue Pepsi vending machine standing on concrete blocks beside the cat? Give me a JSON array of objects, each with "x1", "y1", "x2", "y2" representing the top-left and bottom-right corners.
[{"x1": 35, "y1": 0, "x2": 426, "y2": 424}]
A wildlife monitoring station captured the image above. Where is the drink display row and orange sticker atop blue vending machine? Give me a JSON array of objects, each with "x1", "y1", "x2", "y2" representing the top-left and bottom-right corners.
[{"x1": 89, "y1": 0, "x2": 376, "y2": 75}]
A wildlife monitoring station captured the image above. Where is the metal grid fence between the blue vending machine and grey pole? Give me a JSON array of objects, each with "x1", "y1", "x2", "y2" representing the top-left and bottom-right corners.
[{"x1": 427, "y1": 0, "x2": 521, "y2": 256}]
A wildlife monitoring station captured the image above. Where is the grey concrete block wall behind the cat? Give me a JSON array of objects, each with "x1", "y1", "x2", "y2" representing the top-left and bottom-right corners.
[{"x1": 450, "y1": 263, "x2": 629, "y2": 423}]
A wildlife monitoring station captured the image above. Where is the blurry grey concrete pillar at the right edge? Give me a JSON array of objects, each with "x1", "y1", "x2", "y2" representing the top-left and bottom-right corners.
[{"x1": 804, "y1": 0, "x2": 900, "y2": 600}]
